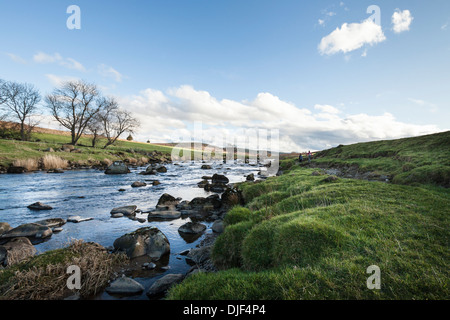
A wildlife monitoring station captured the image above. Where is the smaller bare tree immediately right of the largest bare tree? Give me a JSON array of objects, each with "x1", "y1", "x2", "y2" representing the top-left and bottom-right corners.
[{"x1": 100, "y1": 98, "x2": 140, "y2": 148}]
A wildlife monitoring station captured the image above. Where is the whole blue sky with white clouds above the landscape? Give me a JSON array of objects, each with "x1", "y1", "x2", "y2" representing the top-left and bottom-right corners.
[{"x1": 0, "y1": 0, "x2": 450, "y2": 152}]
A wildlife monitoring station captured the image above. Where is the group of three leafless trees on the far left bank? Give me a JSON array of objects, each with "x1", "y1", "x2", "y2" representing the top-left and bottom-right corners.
[{"x1": 0, "y1": 79, "x2": 139, "y2": 148}]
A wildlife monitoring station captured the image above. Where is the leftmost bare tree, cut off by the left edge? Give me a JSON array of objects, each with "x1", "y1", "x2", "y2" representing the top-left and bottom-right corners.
[{"x1": 0, "y1": 81, "x2": 41, "y2": 140}]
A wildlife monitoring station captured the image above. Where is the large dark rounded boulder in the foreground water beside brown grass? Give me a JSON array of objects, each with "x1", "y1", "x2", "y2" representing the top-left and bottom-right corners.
[{"x1": 114, "y1": 227, "x2": 170, "y2": 260}]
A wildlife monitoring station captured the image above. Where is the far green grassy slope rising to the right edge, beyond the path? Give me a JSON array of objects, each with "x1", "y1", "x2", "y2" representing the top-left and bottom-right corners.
[{"x1": 313, "y1": 131, "x2": 450, "y2": 187}]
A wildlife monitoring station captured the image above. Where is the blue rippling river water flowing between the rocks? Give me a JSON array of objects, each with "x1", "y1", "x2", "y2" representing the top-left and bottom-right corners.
[{"x1": 0, "y1": 162, "x2": 259, "y2": 299}]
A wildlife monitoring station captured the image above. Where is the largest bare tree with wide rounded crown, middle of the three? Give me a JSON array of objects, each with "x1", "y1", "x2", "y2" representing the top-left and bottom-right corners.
[{"x1": 45, "y1": 81, "x2": 105, "y2": 145}]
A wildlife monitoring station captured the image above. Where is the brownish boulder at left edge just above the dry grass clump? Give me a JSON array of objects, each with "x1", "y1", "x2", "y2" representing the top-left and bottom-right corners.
[{"x1": 0, "y1": 237, "x2": 37, "y2": 266}]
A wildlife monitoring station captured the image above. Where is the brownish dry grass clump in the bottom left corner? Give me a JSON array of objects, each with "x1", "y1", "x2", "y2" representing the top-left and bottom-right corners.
[{"x1": 0, "y1": 240, "x2": 127, "y2": 300}]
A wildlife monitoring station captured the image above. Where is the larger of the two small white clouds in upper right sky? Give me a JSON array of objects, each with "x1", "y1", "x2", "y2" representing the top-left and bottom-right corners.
[{"x1": 318, "y1": 19, "x2": 386, "y2": 55}]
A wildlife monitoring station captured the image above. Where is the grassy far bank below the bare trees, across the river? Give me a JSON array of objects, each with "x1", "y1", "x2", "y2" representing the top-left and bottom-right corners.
[{"x1": 0, "y1": 133, "x2": 176, "y2": 168}]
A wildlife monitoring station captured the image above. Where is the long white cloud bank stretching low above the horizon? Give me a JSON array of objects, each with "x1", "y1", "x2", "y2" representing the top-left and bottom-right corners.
[{"x1": 118, "y1": 85, "x2": 440, "y2": 152}]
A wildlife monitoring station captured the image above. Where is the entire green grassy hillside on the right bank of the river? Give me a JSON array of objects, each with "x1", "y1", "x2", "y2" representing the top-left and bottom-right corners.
[{"x1": 169, "y1": 132, "x2": 450, "y2": 300}]
